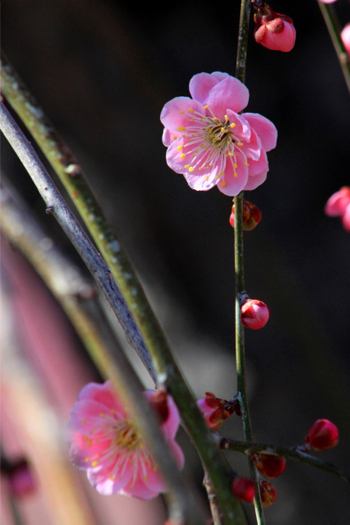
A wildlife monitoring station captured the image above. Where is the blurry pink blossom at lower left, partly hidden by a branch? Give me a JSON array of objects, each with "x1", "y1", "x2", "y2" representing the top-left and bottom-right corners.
[{"x1": 68, "y1": 381, "x2": 184, "y2": 500}]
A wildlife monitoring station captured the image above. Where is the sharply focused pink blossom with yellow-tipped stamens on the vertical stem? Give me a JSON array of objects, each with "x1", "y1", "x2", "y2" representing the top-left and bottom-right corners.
[{"x1": 160, "y1": 71, "x2": 277, "y2": 196}]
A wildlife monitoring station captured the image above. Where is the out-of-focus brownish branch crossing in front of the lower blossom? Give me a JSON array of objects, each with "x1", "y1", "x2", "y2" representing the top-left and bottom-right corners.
[{"x1": 0, "y1": 179, "x2": 205, "y2": 523}]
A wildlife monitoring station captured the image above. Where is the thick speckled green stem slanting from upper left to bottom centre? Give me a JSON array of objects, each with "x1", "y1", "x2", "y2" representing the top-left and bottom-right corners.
[{"x1": 1, "y1": 62, "x2": 246, "y2": 525}]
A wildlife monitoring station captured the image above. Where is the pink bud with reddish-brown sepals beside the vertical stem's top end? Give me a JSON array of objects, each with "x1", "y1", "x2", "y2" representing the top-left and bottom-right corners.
[{"x1": 252, "y1": 0, "x2": 296, "y2": 52}]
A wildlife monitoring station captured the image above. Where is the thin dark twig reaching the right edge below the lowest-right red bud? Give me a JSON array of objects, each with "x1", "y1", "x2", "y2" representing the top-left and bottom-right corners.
[{"x1": 218, "y1": 438, "x2": 350, "y2": 483}]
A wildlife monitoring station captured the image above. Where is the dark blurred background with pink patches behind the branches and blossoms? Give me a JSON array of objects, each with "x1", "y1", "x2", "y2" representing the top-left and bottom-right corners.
[{"x1": 2, "y1": 0, "x2": 350, "y2": 525}]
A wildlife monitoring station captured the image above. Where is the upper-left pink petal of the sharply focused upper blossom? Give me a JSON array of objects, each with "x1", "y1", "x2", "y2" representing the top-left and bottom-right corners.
[{"x1": 160, "y1": 97, "x2": 205, "y2": 134}]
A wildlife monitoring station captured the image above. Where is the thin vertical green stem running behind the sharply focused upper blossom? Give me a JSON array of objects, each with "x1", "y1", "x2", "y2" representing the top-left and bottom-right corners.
[{"x1": 234, "y1": 0, "x2": 265, "y2": 525}]
